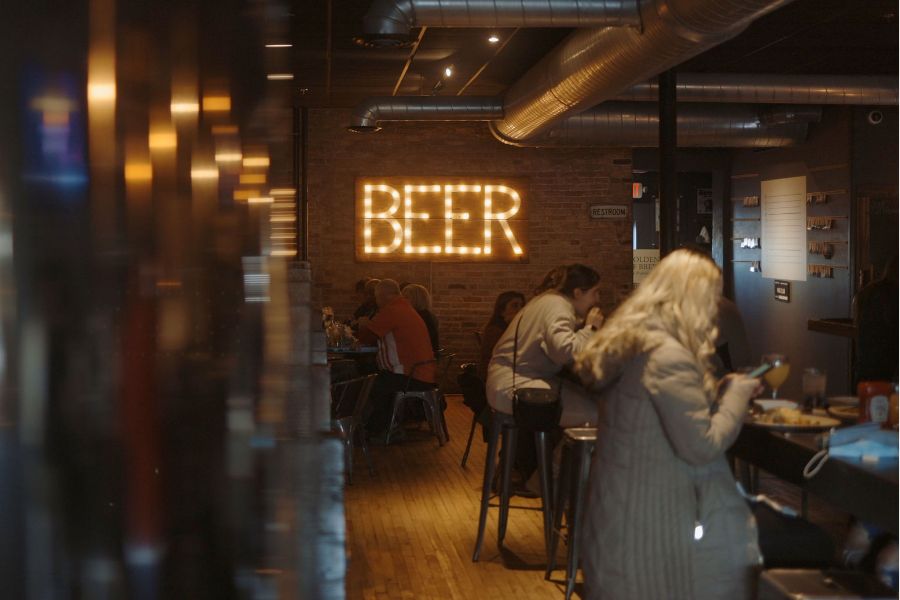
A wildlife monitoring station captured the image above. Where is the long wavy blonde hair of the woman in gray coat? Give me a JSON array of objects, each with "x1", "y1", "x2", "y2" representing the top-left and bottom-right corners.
[{"x1": 575, "y1": 249, "x2": 722, "y2": 392}]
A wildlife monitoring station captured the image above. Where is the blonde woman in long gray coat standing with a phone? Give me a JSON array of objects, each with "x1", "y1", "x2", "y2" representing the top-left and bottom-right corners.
[{"x1": 575, "y1": 250, "x2": 760, "y2": 600}]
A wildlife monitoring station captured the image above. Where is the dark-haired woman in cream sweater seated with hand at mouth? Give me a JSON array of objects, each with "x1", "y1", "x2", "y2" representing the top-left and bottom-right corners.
[{"x1": 486, "y1": 264, "x2": 603, "y2": 427}]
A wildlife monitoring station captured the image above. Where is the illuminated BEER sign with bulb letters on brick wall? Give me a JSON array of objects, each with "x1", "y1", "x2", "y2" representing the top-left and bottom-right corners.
[{"x1": 356, "y1": 177, "x2": 527, "y2": 262}]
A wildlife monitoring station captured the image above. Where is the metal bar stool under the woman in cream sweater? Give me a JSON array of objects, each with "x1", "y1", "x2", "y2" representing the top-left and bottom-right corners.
[{"x1": 472, "y1": 410, "x2": 552, "y2": 562}]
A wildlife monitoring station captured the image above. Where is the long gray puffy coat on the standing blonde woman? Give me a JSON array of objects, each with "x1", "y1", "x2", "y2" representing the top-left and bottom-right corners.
[{"x1": 582, "y1": 336, "x2": 760, "y2": 600}]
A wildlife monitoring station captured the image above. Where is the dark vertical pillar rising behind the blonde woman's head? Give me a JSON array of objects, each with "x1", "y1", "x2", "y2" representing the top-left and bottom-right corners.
[{"x1": 659, "y1": 69, "x2": 678, "y2": 258}]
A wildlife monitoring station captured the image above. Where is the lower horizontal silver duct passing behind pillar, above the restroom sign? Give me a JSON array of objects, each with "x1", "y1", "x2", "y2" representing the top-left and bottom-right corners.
[{"x1": 491, "y1": 102, "x2": 820, "y2": 148}]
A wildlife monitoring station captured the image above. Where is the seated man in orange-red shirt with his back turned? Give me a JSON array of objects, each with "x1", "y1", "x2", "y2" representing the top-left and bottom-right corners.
[{"x1": 359, "y1": 279, "x2": 437, "y2": 435}]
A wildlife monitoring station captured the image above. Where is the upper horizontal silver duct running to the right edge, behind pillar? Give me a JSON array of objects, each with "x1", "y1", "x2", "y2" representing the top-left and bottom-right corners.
[{"x1": 616, "y1": 73, "x2": 897, "y2": 106}]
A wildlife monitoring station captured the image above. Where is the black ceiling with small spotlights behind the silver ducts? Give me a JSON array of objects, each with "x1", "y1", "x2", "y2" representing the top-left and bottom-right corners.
[{"x1": 293, "y1": 0, "x2": 898, "y2": 106}]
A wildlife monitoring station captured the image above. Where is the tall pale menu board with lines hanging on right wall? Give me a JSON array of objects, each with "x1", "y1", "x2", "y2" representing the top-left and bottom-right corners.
[{"x1": 760, "y1": 177, "x2": 806, "y2": 281}]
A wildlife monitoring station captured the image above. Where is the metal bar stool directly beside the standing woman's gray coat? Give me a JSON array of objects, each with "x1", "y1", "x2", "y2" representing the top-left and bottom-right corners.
[{"x1": 544, "y1": 427, "x2": 597, "y2": 600}]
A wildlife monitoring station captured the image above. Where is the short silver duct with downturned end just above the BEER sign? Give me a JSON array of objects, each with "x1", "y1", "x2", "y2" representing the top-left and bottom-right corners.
[{"x1": 347, "y1": 96, "x2": 503, "y2": 133}]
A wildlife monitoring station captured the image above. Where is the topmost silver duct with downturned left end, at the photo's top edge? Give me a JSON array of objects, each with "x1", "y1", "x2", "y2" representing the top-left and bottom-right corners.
[{"x1": 357, "y1": 0, "x2": 640, "y2": 46}]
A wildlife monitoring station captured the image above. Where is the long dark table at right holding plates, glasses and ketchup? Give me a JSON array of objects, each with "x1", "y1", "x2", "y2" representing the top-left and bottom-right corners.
[{"x1": 730, "y1": 424, "x2": 898, "y2": 535}]
